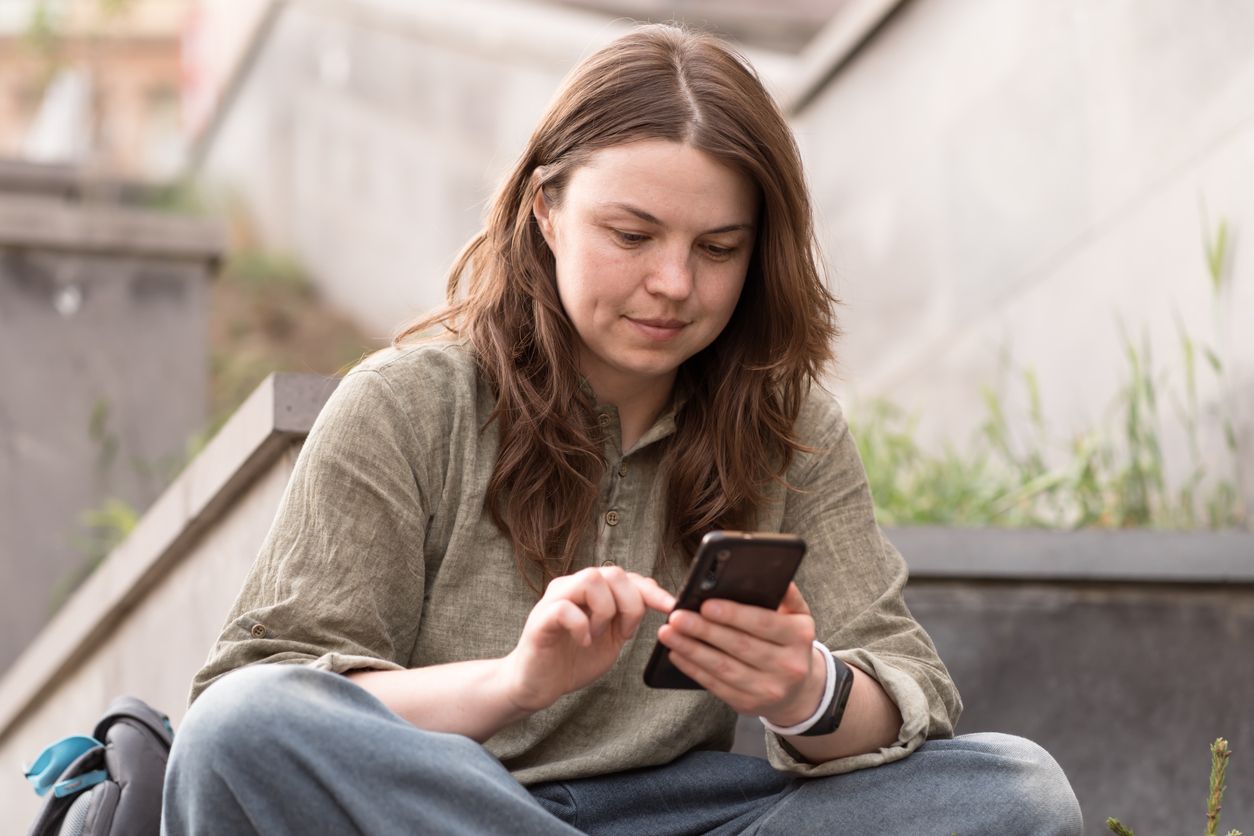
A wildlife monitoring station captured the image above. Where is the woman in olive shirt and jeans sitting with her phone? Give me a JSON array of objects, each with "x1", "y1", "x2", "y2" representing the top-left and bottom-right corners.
[{"x1": 166, "y1": 26, "x2": 1080, "y2": 833}]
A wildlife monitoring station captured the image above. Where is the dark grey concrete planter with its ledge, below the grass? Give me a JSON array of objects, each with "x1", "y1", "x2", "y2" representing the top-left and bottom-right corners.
[{"x1": 888, "y1": 528, "x2": 1254, "y2": 835}]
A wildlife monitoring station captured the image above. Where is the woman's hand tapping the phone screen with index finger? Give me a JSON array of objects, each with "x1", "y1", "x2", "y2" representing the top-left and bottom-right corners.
[{"x1": 502, "y1": 567, "x2": 675, "y2": 713}]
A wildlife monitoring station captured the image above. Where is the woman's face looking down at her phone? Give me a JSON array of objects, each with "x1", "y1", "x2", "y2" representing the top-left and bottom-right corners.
[{"x1": 533, "y1": 139, "x2": 757, "y2": 402}]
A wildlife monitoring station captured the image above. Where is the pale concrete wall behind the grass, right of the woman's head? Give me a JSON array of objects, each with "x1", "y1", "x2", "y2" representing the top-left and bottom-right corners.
[{"x1": 794, "y1": 0, "x2": 1254, "y2": 489}]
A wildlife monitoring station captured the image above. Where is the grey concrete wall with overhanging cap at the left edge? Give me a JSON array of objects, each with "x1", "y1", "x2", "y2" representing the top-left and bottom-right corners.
[{"x1": 0, "y1": 182, "x2": 223, "y2": 672}]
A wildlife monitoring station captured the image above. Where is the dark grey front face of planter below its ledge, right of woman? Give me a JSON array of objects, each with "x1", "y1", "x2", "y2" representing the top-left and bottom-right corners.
[{"x1": 907, "y1": 579, "x2": 1254, "y2": 836}]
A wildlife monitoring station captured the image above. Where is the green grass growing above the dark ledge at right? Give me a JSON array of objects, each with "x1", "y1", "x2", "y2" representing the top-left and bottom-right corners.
[{"x1": 849, "y1": 213, "x2": 1248, "y2": 530}]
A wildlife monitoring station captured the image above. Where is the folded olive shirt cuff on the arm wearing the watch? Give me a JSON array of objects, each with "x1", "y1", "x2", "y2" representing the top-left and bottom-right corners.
[{"x1": 766, "y1": 649, "x2": 929, "y2": 778}]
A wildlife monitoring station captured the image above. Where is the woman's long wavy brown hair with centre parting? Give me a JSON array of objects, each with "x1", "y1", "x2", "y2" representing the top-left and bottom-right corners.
[{"x1": 394, "y1": 25, "x2": 838, "y2": 583}]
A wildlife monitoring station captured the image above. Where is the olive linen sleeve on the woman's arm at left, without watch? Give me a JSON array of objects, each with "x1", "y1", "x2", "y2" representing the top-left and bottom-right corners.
[{"x1": 191, "y1": 368, "x2": 440, "y2": 701}]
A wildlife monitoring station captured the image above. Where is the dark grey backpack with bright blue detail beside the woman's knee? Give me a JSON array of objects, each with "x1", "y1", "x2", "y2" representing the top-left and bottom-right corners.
[{"x1": 25, "y1": 697, "x2": 174, "y2": 836}]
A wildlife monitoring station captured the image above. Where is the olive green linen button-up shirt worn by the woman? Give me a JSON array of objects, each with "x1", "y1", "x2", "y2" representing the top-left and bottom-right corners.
[{"x1": 192, "y1": 343, "x2": 962, "y2": 783}]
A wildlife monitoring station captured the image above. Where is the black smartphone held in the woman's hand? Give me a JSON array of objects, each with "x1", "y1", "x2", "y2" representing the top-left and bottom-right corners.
[{"x1": 645, "y1": 531, "x2": 805, "y2": 691}]
